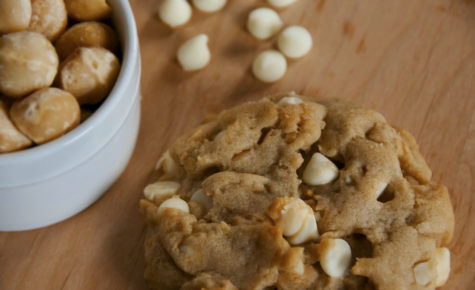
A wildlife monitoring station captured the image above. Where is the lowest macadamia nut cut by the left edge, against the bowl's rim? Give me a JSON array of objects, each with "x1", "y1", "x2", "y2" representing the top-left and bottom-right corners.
[{"x1": 0, "y1": 100, "x2": 31, "y2": 153}]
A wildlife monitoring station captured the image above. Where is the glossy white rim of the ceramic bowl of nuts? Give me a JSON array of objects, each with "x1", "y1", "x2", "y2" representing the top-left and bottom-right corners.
[{"x1": 0, "y1": 0, "x2": 138, "y2": 163}]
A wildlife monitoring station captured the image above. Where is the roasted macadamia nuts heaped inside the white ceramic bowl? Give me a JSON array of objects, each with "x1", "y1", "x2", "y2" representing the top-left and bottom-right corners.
[{"x1": 0, "y1": 0, "x2": 120, "y2": 153}]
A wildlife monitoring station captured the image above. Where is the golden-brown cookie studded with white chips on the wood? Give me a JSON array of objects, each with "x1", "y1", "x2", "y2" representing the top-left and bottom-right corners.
[{"x1": 140, "y1": 94, "x2": 454, "y2": 289}]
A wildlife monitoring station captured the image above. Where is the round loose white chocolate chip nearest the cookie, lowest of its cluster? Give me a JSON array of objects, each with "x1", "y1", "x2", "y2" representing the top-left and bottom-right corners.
[{"x1": 252, "y1": 50, "x2": 287, "y2": 83}]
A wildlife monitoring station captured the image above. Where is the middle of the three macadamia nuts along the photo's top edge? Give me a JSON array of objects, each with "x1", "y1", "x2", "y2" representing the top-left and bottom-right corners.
[{"x1": 28, "y1": 0, "x2": 68, "y2": 41}]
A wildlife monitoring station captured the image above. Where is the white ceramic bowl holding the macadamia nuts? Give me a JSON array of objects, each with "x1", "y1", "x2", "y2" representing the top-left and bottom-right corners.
[{"x1": 0, "y1": 0, "x2": 141, "y2": 231}]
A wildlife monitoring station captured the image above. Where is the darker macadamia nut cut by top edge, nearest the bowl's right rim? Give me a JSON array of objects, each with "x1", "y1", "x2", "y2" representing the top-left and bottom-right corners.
[{"x1": 64, "y1": 0, "x2": 111, "y2": 21}]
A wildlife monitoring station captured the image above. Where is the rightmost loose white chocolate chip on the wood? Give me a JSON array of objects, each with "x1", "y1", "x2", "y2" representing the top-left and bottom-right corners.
[{"x1": 277, "y1": 25, "x2": 312, "y2": 58}]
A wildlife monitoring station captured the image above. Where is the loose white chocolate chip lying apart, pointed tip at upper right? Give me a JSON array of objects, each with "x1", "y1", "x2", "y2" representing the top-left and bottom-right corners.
[{"x1": 177, "y1": 34, "x2": 211, "y2": 71}]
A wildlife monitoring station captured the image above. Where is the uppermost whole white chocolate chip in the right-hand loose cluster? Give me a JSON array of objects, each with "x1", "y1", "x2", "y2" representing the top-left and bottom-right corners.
[{"x1": 247, "y1": 8, "x2": 282, "y2": 39}]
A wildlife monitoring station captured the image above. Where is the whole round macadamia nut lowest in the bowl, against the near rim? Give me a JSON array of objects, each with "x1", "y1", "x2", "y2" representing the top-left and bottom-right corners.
[{"x1": 10, "y1": 88, "x2": 80, "y2": 144}]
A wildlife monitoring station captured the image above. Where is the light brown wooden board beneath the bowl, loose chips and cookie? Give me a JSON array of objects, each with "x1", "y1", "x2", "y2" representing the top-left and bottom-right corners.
[{"x1": 0, "y1": 0, "x2": 475, "y2": 290}]
